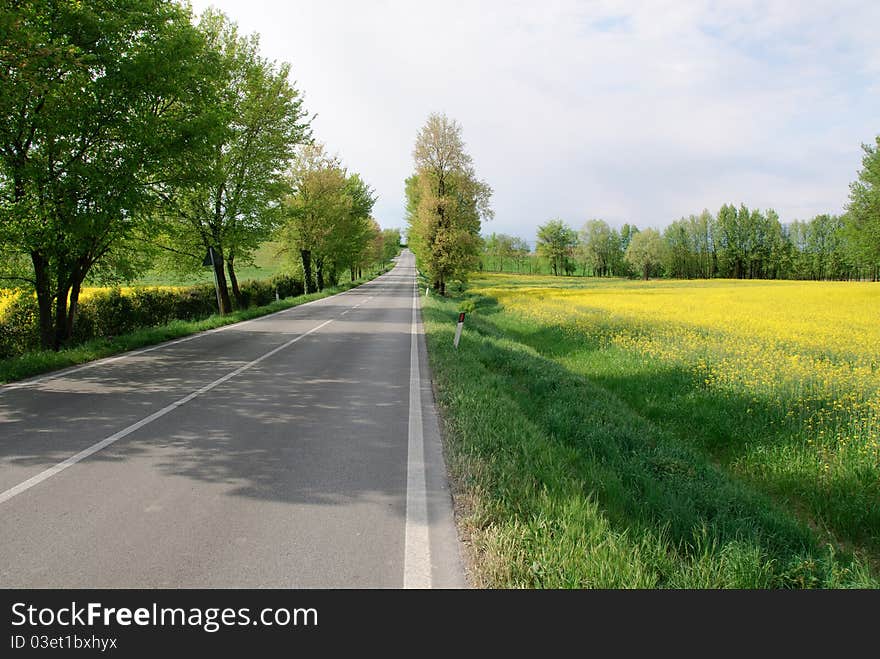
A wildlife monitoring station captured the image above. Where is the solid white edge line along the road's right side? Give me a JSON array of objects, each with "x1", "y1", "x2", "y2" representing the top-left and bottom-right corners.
[{"x1": 403, "y1": 276, "x2": 431, "y2": 588}]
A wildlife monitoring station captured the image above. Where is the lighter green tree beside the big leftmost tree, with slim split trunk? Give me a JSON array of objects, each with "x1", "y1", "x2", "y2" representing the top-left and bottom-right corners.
[{"x1": 153, "y1": 10, "x2": 309, "y2": 313}]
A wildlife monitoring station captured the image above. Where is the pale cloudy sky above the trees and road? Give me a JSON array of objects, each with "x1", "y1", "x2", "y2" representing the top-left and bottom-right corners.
[{"x1": 191, "y1": 0, "x2": 880, "y2": 242}]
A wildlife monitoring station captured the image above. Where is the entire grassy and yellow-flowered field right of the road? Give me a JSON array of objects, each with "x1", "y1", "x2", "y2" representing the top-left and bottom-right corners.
[{"x1": 425, "y1": 274, "x2": 880, "y2": 588}]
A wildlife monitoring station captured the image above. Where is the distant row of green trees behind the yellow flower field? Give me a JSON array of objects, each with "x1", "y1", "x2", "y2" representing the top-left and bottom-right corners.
[{"x1": 483, "y1": 137, "x2": 880, "y2": 281}]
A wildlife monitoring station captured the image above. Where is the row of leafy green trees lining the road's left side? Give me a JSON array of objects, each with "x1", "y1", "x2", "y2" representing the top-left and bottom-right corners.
[{"x1": 0, "y1": 0, "x2": 399, "y2": 349}]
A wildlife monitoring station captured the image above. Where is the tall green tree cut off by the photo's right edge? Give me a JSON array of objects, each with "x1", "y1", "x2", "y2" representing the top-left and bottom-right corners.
[{"x1": 845, "y1": 136, "x2": 880, "y2": 281}]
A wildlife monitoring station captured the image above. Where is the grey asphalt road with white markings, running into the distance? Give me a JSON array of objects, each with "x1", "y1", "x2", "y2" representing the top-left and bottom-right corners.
[{"x1": 0, "y1": 251, "x2": 466, "y2": 588}]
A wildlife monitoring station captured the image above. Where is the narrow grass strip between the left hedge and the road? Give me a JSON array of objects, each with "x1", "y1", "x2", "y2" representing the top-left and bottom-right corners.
[{"x1": 0, "y1": 273, "x2": 381, "y2": 384}]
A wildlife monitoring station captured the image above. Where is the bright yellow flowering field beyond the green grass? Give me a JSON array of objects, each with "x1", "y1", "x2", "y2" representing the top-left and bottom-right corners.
[{"x1": 473, "y1": 275, "x2": 880, "y2": 478}]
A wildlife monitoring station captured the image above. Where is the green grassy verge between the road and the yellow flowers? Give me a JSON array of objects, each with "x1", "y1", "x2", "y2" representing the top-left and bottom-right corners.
[{"x1": 423, "y1": 284, "x2": 880, "y2": 588}]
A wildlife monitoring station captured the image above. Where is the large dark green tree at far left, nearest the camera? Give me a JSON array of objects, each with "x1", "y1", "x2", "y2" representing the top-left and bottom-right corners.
[{"x1": 0, "y1": 0, "x2": 215, "y2": 349}]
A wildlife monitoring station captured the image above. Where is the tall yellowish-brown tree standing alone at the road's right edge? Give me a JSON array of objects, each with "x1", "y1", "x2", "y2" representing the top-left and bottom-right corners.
[{"x1": 405, "y1": 114, "x2": 494, "y2": 295}]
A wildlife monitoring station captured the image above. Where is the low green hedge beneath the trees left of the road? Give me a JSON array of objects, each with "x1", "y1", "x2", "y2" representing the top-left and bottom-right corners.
[{"x1": 0, "y1": 275, "x2": 305, "y2": 359}]
